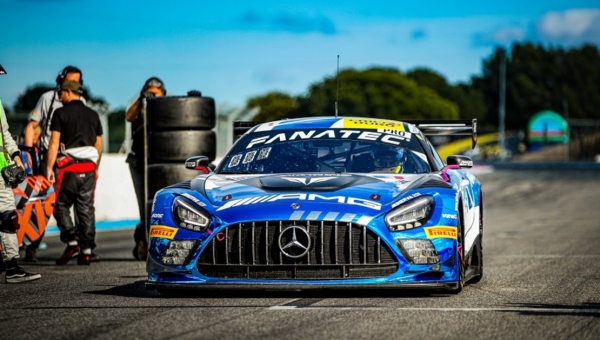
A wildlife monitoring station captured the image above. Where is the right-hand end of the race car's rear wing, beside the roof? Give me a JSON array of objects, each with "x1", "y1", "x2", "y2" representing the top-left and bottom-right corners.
[{"x1": 404, "y1": 118, "x2": 477, "y2": 148}]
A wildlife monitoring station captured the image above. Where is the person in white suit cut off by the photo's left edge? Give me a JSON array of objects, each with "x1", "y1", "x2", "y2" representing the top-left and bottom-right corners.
[{"x1": 0, "y1": 65, "x2": 42, "y2": 283}]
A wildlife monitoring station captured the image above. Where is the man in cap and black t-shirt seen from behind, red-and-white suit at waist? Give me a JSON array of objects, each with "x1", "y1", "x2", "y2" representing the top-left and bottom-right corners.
[{"x1": 46, "y1": 80, "x2": 103, "y2": 265}]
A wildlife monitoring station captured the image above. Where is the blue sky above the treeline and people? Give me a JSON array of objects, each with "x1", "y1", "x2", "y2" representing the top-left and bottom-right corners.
[{"x1": 0, "y1": 0, "x2": 600, "y2": 109}]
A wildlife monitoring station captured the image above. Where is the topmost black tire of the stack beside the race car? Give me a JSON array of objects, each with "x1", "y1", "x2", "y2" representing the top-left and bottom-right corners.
[{"x1": 146, "y1": 96, "x2": 216, "y2": 131}]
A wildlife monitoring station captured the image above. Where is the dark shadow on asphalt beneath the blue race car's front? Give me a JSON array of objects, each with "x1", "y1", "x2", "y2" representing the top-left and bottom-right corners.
[{"x1": 85, "y1": 280, "x2": 454, "y2": 299}]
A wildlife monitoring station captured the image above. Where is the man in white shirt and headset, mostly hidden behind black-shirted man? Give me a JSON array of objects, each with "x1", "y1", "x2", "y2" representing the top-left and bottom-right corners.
[{"x1": 24, "y1": 65, "x2": 100, "y2": 262}]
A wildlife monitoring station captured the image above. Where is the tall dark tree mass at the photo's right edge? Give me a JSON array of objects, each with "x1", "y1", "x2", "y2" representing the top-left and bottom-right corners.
[{"x1": 473, "y1": 43, "x2": 600, "y2": 129}]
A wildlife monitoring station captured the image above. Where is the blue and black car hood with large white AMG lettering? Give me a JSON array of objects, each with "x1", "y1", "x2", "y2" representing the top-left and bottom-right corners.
[{"x1": 191, "y1": 173, "x2": 429, "y2": 210}]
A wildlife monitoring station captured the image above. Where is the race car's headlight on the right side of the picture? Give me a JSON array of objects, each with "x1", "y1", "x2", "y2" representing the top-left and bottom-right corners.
[{"x1": 385, "y1": 196, "x2": 433, "y2": 231}]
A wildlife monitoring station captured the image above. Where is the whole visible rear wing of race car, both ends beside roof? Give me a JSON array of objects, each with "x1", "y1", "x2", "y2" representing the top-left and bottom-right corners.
[{"x1": 233, "y1": 118, "x2": 477, "y2": 148}]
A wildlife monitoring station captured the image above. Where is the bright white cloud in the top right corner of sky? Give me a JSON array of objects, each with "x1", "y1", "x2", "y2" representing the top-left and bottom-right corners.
[{"x1": 535, "y1": 9, "x2": 600, "y2": 44}]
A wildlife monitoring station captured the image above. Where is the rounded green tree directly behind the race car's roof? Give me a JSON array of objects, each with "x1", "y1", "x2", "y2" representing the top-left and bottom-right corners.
[{"x1": 295, "y1": 68, "x2": 458, "y2": 120}]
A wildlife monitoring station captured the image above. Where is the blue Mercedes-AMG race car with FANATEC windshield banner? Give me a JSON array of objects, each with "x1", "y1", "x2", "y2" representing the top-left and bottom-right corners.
[{"x1": 146, "y1": 117, "x2": 483, "y2": 293}]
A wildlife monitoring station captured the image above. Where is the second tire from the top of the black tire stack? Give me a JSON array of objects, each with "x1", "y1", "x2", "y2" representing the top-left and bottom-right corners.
[{"x1": 148, "y1": 130, "x2": 217, "y2": 164}]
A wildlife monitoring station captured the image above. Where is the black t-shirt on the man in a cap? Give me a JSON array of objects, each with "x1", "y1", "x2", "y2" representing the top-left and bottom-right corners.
[{"x1": 50, "y1": 100, "x2": 102, "y2": 149}]
